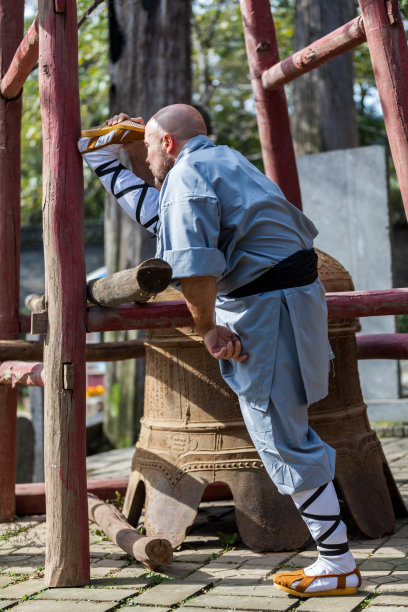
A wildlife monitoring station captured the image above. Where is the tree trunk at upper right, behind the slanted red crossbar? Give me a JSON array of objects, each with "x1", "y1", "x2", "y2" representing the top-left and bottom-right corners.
[{"x1": 292, "y1": 0, "x2": 358, "y2": 155}]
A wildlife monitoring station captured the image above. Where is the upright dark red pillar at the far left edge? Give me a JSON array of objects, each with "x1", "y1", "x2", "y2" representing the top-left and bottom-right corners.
[{"x1": 0, "y1": 0, "x2": 24, "y2": 520}]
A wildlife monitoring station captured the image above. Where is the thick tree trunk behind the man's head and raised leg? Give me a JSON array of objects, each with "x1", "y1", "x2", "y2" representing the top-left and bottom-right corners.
[{"x1": 104, "y1": 0, "x2": 191, "y2": 446}]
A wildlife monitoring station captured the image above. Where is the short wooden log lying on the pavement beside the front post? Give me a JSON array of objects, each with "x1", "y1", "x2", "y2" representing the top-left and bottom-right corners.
[{"x1": 88, "y1": 493, "x2": 173, "y2": 569}]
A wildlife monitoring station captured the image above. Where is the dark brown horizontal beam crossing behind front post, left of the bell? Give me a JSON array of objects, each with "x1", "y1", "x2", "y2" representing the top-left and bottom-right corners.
[{"x1": 0, "y1": 338, "x2": 146, "y2": 362}]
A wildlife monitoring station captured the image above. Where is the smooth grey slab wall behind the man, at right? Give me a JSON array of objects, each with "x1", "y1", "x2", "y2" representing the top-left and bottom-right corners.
[{"x1": 297, "y1": 145, "x2": 408, "y2": 420}]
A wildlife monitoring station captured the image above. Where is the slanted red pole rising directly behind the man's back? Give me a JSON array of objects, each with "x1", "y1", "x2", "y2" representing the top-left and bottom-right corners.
[{"x1": 240, "y1": 0, "x2": 302, "y2": 208}]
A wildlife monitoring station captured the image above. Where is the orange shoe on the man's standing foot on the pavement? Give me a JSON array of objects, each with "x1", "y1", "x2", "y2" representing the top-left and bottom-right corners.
[{"x1": 273, "y1": 568, "x2": 361, "y2": 597}]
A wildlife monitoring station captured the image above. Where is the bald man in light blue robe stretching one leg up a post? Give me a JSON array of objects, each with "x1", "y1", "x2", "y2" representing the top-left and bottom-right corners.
[{"x1": 78, "y1": 104, "x2": 361, "y2": 597}]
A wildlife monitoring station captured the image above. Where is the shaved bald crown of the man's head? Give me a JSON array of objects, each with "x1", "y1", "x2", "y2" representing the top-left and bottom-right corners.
[{"x1": 146, "y1": 104, "x2": 207, "y2": 143}]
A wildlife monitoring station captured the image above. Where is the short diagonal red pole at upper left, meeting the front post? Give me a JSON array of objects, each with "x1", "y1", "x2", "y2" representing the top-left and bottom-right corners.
[{"x1": 0, "y1": 19, "x2": 38, "y2": 100}]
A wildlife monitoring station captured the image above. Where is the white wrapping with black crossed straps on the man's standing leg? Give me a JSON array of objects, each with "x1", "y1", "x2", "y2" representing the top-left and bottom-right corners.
[{"x1": 292, "y1": 482, "x2": 359, "y2": 593}]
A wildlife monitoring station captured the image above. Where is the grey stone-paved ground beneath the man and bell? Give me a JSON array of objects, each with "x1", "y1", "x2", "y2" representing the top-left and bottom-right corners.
[{"x1": 0, "y1": 438, "x2": 408, "y2": 612}]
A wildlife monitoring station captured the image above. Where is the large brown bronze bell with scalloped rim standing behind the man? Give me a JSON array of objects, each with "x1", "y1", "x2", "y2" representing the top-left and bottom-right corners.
[{"x1": 124, "y1": 253, "x2": 405, "y2": 551}]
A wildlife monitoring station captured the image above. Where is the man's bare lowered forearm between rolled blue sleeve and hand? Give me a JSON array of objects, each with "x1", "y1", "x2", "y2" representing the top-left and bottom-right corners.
[{"x1": 180, "y1": 276, "x2": 217, "y2": 336}]
